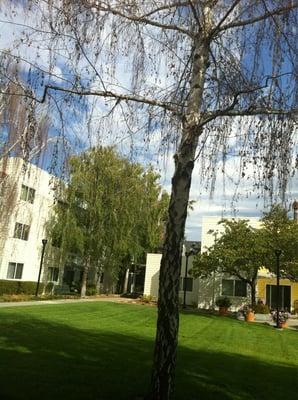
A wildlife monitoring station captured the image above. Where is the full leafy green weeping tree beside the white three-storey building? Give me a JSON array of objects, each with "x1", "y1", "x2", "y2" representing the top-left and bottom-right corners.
[{"x1": 49, "y1": 147, "x2": 167, "y2": 296}]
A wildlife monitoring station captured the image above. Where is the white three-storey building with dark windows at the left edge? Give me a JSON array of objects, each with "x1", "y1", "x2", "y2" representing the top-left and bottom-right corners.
[{"x1": 0, "y1": 157, "x2": 59, "y2": 281}]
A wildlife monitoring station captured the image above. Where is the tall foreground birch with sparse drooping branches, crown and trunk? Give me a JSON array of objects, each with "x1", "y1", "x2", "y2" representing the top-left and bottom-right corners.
[{"x1": 0, "y1": 0, "x2": 298, "y2": 400}]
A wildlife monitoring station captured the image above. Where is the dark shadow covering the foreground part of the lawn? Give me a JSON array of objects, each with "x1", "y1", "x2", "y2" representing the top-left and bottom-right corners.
[{"x1": 0, "y1": 316, "x2": 298, "y2": 400}]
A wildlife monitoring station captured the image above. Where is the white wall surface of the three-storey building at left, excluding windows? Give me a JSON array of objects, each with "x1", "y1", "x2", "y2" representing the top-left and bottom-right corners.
[{"x1": 0, "y1": 157, "x2": 56, "y2": 281}]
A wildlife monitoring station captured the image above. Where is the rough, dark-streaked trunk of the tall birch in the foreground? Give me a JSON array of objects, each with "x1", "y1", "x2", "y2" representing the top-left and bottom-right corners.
[{"x1": 148, "y1": 32, "x2": 209, "y2": 400}]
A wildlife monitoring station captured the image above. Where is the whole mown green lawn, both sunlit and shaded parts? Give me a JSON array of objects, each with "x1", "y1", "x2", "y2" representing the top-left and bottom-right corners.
[{"x1": 0, "y1": 302, "x2": 298, "y2": 400}]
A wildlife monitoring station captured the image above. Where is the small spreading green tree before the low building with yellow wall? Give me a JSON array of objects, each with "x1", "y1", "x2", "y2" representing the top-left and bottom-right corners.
[{"x1": 192, "y1": 206, "x2": 298, "y2": 305}]
